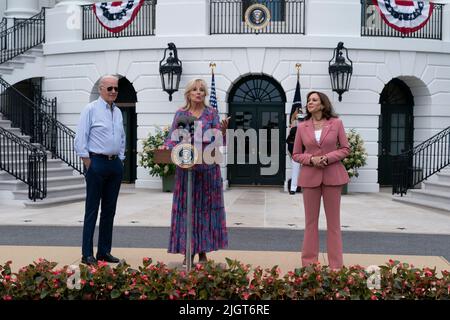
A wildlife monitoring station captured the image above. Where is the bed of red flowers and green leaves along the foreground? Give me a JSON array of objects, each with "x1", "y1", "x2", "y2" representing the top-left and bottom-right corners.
[{"x1": 0, "y1": 258, "x2": 450, "y2": 300}]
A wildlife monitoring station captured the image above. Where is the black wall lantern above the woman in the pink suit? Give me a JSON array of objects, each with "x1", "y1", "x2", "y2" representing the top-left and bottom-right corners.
[{"x1": 328, "y1": 42, "x2": 353, "y2": 101}]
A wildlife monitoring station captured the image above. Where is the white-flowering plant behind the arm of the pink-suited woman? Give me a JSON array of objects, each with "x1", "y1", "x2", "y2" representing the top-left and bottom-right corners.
[{"x1": 342, "y1": 129, "x2": 367, "y2": 194}]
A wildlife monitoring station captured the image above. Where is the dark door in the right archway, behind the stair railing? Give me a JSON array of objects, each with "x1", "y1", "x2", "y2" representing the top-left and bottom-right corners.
[{"x1": 378, "y1": 105, "x2": 414, "y2": 186}]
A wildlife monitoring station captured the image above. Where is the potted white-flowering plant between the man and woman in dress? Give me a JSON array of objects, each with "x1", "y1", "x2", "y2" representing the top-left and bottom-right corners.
[{"x1": 139, "y1": 127, "x2": 176, "y2": 192}]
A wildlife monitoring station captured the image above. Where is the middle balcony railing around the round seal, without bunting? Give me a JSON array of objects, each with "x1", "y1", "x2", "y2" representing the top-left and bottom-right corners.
[{"x1": 209, "y1": 0, "x2": 305, "y2": 34}]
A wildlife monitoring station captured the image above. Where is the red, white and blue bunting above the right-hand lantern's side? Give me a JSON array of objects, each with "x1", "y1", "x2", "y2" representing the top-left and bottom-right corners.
[{"x1": 373, "y1": 0, "x2": 433, "y2": 33}]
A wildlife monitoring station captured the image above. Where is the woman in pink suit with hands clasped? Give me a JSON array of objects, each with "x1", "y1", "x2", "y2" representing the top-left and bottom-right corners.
[{"x1": 292, "y1": 91, "x2": 350, "y2": 269}]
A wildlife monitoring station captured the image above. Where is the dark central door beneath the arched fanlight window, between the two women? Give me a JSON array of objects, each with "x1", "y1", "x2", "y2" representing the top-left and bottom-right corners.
[{"x1": 228, "y1": 104, "x2": 286, "y2": 185}]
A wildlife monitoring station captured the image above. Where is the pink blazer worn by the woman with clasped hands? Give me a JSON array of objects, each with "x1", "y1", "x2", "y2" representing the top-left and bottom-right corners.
[{"x1": 292, "y1": 118, "x2": 350, "y2": 188}]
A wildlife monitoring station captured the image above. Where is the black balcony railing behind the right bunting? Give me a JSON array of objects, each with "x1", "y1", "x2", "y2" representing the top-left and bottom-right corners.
[{"x1": 361, "y1": 0, "x2": 448, "y2": 40}]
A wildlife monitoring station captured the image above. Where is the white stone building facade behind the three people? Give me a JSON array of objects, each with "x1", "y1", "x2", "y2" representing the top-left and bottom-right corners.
[{"x1": 4, "y1": 0, "x2": 450, "y2": 192}]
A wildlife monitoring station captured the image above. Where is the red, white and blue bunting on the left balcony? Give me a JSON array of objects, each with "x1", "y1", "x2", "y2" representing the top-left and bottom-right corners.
[{"x1": 92, "y1": 0, "x2": 144, "y2": 33}]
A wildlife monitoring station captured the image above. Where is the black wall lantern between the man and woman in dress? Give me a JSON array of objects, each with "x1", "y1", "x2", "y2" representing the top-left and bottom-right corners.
[{"x1": 159, "y1": 42, "x2": 182, "y2": 101}]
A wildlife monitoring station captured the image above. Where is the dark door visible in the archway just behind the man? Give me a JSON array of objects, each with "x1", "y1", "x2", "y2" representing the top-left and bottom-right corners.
[{"x1": 120, "y1": 107, "x2": 137, "y2": 183}]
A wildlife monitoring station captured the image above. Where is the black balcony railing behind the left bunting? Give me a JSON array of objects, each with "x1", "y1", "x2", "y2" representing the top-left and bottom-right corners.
[{"x1": 82, "y1": 0, "x2": 157, "y2": 40}]
